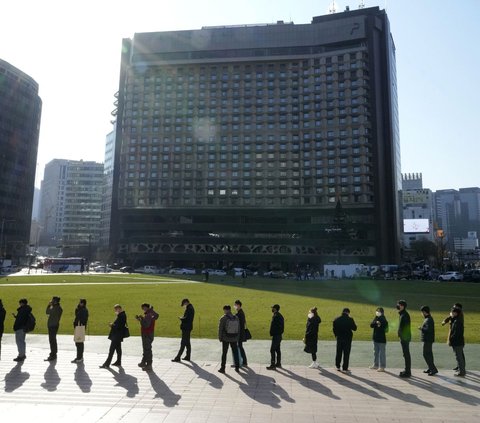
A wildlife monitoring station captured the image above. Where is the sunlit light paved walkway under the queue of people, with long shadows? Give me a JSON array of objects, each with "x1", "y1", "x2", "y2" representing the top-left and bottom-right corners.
[{"x1": 0, "y1": 334, "x2": 480, "y2": 423}]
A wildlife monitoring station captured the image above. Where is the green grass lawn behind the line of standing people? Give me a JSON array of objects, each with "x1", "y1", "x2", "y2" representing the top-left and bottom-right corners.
[{"x1": 0, "y1": 274, "x2": 480, "y2": 343}]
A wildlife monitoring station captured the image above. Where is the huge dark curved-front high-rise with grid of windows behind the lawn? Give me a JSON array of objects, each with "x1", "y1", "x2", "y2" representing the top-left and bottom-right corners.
[{"x1": 111, "y1": 7, "x2": 401, "y2": 268}]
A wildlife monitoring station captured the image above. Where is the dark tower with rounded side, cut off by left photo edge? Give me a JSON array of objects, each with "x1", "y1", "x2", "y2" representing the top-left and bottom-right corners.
[{"x1": 0, "y1": 60, "x2": 42, "y2": 260}]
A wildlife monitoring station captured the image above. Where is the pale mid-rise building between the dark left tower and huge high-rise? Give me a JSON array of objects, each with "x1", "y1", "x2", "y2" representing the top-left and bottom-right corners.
[{"x1": 40, "y1": 159, "x2": 103, "y2": 255}]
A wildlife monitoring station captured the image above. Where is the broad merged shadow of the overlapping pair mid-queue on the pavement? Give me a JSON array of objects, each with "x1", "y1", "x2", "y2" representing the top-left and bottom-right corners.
[{"x1": 225, "y1": 367, "x2": 295, "y2": 408}]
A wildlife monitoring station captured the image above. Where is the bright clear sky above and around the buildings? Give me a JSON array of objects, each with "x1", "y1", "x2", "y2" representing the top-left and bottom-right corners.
[{"x1": 0, "y1": 0, "x2": 480, "y2": 190}]
